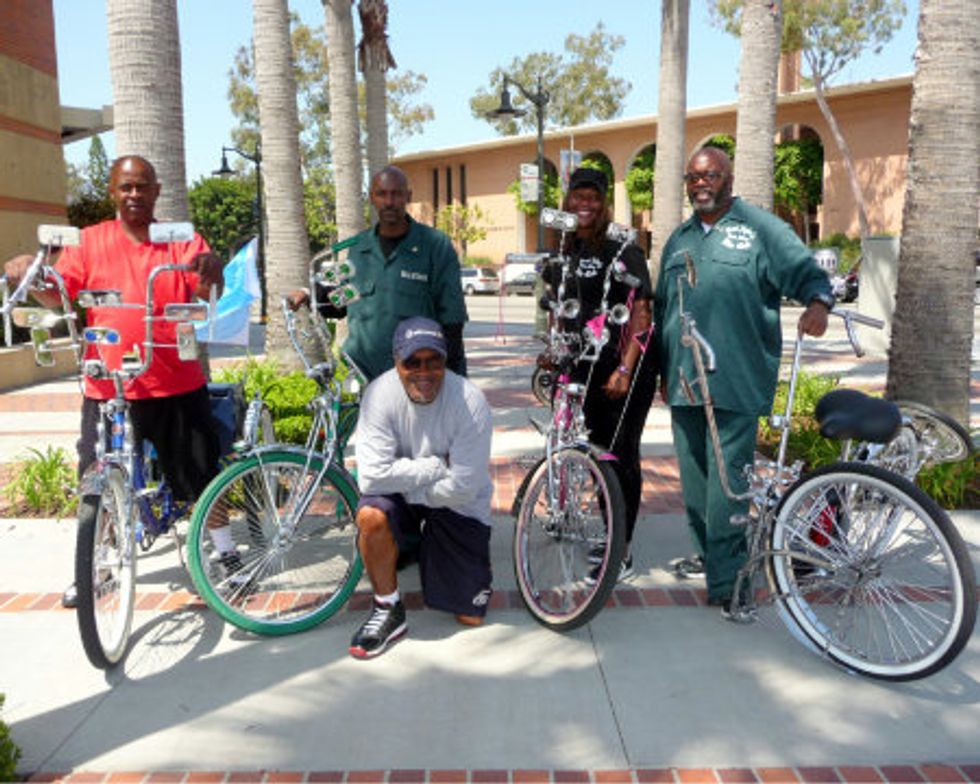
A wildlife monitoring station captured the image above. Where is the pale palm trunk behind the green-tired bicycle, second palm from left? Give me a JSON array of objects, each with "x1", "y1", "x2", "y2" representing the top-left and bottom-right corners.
[{"x1": 252, "y1": 0, "x2": 310, "y2": 366}]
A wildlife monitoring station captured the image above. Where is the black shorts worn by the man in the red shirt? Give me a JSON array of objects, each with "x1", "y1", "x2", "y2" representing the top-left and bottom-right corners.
[{"x1": 77, "y1": 386, "x2": 220, "y2": 501}]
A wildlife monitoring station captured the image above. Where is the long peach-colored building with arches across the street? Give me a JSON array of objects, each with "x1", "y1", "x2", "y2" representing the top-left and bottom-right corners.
[{"x1": 393, "y1": 75, "x2": 912, "y2": 264}]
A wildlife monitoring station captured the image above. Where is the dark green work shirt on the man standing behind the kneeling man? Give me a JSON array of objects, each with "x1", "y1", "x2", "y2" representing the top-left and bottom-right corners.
[{"x1": 344, "y1": 218, "x2": 467, "y2": 379}]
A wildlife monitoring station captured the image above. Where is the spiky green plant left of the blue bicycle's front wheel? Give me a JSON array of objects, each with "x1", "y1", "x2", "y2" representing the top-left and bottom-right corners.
[{"x1": 3, "y1": 445, "x2": 78, "y2": 517}]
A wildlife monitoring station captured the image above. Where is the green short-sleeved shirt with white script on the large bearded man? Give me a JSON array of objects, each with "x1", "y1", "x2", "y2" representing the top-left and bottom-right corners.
[{"x1": 654, "y1": 199, "x2": 831, "y2": 416}]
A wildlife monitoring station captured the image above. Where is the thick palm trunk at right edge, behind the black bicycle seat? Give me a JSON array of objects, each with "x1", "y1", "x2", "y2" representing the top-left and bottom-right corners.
[{"x1": 887, "y1": 0, "x2": 980, "y2": 425}]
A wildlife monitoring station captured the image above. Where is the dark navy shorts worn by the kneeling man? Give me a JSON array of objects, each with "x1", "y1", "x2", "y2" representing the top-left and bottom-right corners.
[{"x1": 357, "y1": 493, "x2": 493, "y2": 617}]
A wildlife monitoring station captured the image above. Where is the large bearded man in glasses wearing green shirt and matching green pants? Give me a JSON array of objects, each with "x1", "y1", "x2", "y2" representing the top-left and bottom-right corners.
[{"x1": 654, "y1": 147, "x2": 834, "y2": 617}]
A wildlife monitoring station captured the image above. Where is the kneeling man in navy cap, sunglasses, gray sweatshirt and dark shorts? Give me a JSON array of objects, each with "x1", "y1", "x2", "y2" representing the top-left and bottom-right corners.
[{"x1": 350, "y1": 317, "x2": 493, "y2": 659}]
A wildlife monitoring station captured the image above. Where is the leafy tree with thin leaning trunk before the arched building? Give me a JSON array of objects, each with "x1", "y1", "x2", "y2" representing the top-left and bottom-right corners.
[{"x1": 712, "y1": 0, "x2": 905, "y2": 237}]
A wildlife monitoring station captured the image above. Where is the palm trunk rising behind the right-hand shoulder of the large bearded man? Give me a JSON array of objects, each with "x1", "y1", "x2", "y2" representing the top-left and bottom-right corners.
[{"x1": 735, "y1": 0, "x2": 783, "y2": 210}]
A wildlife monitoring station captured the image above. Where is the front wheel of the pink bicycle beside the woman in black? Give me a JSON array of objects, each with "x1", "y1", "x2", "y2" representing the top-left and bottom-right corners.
[{"x1": 513, "y1": 448, "x2": 626, "y2": 632}]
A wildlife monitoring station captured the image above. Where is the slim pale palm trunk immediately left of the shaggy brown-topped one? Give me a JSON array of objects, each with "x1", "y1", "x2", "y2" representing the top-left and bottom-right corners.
[{"x1": 323, "y1": 0, "x2": 364, "y2": 240}]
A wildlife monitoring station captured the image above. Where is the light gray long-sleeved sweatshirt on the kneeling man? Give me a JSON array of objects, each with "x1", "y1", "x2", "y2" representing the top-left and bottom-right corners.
[{"x1": 355, "y1": 369, "x2": 493, "y2": 525}]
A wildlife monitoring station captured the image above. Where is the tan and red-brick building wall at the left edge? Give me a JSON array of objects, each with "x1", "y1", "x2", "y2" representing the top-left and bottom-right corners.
[{"x1": 0, "y1": 0, "x2": 66, "y2": 260}]
